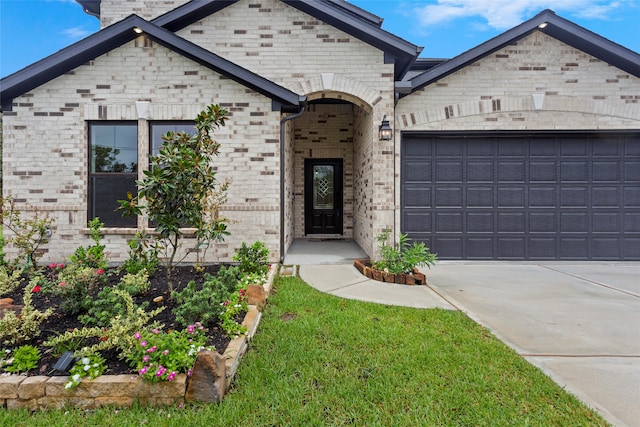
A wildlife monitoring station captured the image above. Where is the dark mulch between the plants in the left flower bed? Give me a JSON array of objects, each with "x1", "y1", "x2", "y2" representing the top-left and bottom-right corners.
[{"x1": 7, "y1": 265, "x2": 236, "y2": 376}]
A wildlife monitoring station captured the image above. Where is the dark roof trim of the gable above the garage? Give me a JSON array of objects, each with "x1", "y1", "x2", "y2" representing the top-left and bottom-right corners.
[{"x1": 408, "y1": 9, "x2": 640, "y2": 96}]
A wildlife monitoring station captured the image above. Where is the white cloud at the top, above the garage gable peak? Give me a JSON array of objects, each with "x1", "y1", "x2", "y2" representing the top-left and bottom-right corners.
[{"x1": 415, "y1": 0, "x2": 624, "y2": 30}]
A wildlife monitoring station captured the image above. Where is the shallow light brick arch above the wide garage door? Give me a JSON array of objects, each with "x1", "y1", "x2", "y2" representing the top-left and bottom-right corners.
[{"x1": 396, "y1": 95, "x2": 639, "y2": 130}]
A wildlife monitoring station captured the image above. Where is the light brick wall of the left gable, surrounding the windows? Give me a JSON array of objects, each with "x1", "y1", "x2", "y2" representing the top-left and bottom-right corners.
[{"x1": 3, "y1": 37, "x2": 280, "y2": 262}]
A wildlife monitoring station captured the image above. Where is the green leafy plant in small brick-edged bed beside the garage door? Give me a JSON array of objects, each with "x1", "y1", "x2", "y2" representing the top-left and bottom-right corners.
[{"x1": 373, "y1": 229, "x2": 438, "y2": 274}]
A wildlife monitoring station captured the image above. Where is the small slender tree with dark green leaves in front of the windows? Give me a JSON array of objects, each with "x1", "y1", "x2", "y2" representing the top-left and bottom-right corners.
[{"x1": 119, "y1": 105, "x2": 228, "y2": 293}]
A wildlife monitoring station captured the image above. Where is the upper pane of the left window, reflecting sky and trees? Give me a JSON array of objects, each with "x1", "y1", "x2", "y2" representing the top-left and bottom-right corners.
[{"x1": 91, "y1": 124, "x2": 138, "y2": 173}]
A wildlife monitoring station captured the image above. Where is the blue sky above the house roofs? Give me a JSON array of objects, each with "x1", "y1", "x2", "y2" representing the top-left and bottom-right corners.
[{"x1": 0, "y1": 0, "x2": 640, "y2": 77}]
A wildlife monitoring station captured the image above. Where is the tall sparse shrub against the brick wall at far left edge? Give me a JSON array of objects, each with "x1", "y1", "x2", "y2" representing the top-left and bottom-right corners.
[{"x1": 0, "y1": 196, "x2": 55, "y2": 269}]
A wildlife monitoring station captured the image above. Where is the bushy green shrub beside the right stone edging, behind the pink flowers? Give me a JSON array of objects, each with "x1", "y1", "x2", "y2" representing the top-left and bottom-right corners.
[{"x1": 173, "y1": 266, "x2": 239, "y2": 326}]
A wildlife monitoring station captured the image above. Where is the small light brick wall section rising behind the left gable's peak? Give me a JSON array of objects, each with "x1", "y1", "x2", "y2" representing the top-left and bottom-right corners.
[{"x1": 100, "y1": 0, "x2": 190, "y2": 28}]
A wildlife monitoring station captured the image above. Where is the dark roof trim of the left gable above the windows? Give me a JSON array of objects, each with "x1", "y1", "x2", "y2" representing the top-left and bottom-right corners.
[{"x1": 0, "y1": 15, "x2": 306, "y2": 111}]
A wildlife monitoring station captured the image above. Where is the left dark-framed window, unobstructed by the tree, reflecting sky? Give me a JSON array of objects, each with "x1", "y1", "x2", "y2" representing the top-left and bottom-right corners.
[{"x1": 89, "y1": 122, "x2": 138, "y2": 228}]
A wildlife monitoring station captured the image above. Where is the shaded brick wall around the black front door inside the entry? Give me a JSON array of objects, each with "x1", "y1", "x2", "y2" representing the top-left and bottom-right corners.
[{"x1": 294, "y1": 104, "x2": 357, "y2": 238}]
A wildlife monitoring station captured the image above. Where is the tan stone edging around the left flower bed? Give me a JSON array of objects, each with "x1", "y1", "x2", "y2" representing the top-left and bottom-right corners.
[{"x1": 0, "y1": 265, "x2": 277, "y2": 410}]
